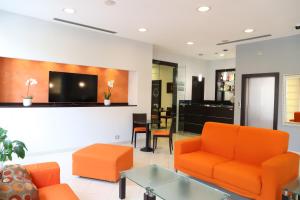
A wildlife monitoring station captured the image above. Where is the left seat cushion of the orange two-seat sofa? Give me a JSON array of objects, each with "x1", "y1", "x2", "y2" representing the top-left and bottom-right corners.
[{"x1": 178, "y1": 151, "x2": 228, "y2": 178}]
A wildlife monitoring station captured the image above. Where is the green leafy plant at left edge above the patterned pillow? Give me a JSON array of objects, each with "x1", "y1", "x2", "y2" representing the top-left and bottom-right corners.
[{"x1": 0, "y1": 128, "x2": 27, "y2": 171}]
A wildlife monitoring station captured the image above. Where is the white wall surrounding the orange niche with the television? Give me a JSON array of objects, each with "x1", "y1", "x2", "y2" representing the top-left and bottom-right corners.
[{"x1": 0, "y1": 11, "x2": 153, "y2": 153}]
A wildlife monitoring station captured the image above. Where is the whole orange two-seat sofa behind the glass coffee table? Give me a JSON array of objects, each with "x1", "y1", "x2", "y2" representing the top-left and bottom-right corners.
[{"x1": 174, "y1": 122, "x2": 299, "y2": 200}]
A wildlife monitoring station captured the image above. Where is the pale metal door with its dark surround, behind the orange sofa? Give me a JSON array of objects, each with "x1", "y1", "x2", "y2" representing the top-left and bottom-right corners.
[{"x1": 241, "y1": 73, "x2": 279, "y2": 130}]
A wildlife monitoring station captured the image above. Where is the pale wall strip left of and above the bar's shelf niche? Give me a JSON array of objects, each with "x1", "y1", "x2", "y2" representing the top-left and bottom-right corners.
[{"x1": 205, "y1": 58, "x2": 236, "y2": 100}]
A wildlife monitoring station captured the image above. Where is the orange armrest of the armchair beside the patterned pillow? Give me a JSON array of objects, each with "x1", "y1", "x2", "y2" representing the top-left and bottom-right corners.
[{"x1": 25, "y1": 162, "x2": 60, "y2": 188}]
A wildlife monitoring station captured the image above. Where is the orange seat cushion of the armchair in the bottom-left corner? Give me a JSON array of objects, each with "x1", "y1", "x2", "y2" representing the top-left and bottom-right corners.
[{"x1": 39, "y1": 184, "x2": 79, "y2": 200}]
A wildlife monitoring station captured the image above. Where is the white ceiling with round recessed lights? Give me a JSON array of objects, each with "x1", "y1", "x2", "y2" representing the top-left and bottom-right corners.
[{"x1": 0, "y1": 0, "x2": 300, "y2": 59}]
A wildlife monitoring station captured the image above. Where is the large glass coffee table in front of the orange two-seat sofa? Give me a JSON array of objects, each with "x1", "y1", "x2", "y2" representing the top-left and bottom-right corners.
[{"x1": 119, "y1": 165, "x2": 232, "y2": 200}]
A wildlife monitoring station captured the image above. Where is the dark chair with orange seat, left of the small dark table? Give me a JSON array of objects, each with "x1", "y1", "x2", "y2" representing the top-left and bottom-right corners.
[{"x1": 131, "y1": 113, "x2": 147, "y2": 148}]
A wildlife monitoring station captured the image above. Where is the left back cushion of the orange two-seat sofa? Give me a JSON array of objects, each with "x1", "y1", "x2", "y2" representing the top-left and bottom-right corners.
[{"x1": 201, "y1": 122, "x2": 239, "y2": 159}]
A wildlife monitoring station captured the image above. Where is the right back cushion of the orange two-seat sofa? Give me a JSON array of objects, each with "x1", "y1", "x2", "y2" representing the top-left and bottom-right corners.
[{"x1": 235, "y1": 126, "x2": 289, "y2": 165}]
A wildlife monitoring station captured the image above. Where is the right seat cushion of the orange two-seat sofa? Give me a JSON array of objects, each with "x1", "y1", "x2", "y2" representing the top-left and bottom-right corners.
[{"x1": 213, "y1": 161, "x2": 262, "y2": 194}]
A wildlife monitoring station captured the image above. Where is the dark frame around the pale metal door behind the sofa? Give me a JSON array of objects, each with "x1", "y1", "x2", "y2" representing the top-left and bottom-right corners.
[{"x1": 241, "y1": 72, "x2": 280, "y2": 130}]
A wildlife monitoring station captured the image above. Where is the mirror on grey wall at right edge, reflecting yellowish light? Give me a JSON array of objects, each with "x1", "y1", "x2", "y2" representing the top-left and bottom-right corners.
[{"x1": 283, "y1": 74, "x2": 300, "y2": 125}]
